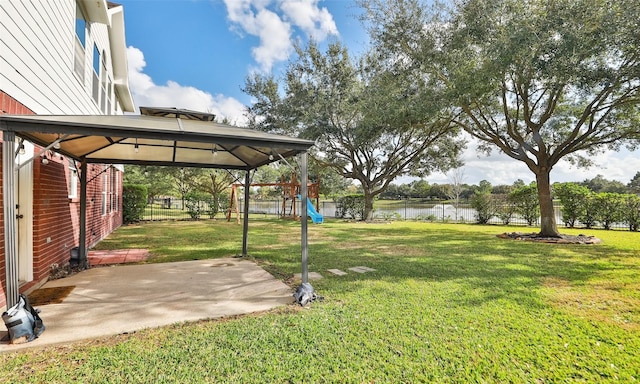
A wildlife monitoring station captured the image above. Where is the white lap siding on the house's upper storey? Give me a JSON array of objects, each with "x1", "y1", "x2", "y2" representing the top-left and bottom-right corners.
[{"x1": 0, "y1": 0, "x2": 121, "y2": 114}]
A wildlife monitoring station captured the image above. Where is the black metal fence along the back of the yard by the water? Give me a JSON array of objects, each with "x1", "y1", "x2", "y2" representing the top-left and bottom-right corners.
[{"x1": 143, "y1": 199, "x2": 628, "y2": 229}]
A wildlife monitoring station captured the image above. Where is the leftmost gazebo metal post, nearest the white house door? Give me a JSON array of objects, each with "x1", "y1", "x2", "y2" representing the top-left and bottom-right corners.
[{"x1": 2, "y1": 131, "x2": 19, "y2": 308}]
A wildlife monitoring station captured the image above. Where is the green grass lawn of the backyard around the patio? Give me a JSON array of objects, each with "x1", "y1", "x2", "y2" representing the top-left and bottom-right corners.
[{"x1": 0, "y1": 217, "x2": 640, "y2": 383}]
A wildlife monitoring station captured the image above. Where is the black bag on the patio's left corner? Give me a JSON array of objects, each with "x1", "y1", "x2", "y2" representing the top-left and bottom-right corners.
[{"x1": 2, "y1": 294, "x2": 45, "y2": 342}]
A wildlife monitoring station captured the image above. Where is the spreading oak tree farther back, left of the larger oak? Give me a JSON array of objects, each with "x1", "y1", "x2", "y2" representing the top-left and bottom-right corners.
[{"x1": 244, "y1": 42, "x2": 463, "y2": 220}]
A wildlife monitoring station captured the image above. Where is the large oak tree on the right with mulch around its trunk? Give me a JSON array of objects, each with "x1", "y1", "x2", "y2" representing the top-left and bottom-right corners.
[{"x1": 360, "y1": 0, "x2": 640, "y2": 236}]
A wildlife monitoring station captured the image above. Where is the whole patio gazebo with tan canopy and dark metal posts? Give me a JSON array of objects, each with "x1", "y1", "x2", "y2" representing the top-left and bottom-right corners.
[{"x1": 0, "y1": 108, "x2": 314, "y2": 308}]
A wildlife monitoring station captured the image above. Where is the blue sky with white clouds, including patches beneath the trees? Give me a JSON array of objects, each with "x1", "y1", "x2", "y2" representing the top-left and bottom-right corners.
[{"x1": 118, "y1": 0, "x2": 640, "y2": 185}]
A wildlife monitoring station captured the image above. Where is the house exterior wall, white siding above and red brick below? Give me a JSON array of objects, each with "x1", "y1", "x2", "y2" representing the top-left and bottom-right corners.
[{"x1": 0, "y1": 0, "x2": 132, "y2": 310}]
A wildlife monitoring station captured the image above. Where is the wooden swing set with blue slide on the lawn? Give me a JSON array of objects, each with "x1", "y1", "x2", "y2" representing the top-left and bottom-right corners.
[{"x1": 227, "y1": 173, "x2": 324, "y2": 224}]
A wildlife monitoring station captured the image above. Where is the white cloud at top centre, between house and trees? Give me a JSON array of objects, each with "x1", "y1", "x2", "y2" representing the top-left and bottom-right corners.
[{"x1": 224, "y1": 0, "x2": 338, "y2": 72}]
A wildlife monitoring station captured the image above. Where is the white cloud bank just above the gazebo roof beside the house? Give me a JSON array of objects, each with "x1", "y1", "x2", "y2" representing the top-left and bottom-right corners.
[{"x1": 127, "y1": 46, "x2": 246, "y2": 126}]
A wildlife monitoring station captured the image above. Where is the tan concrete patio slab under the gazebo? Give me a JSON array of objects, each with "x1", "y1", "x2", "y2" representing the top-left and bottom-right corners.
[{"x1": 0, "y1": 258, "x2": 294, "y2": 352}]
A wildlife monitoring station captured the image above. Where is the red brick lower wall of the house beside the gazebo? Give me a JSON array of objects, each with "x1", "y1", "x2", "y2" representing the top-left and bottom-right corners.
[{"x1": 0, "y1": 91, "x2": 122, "y2": 309}]
